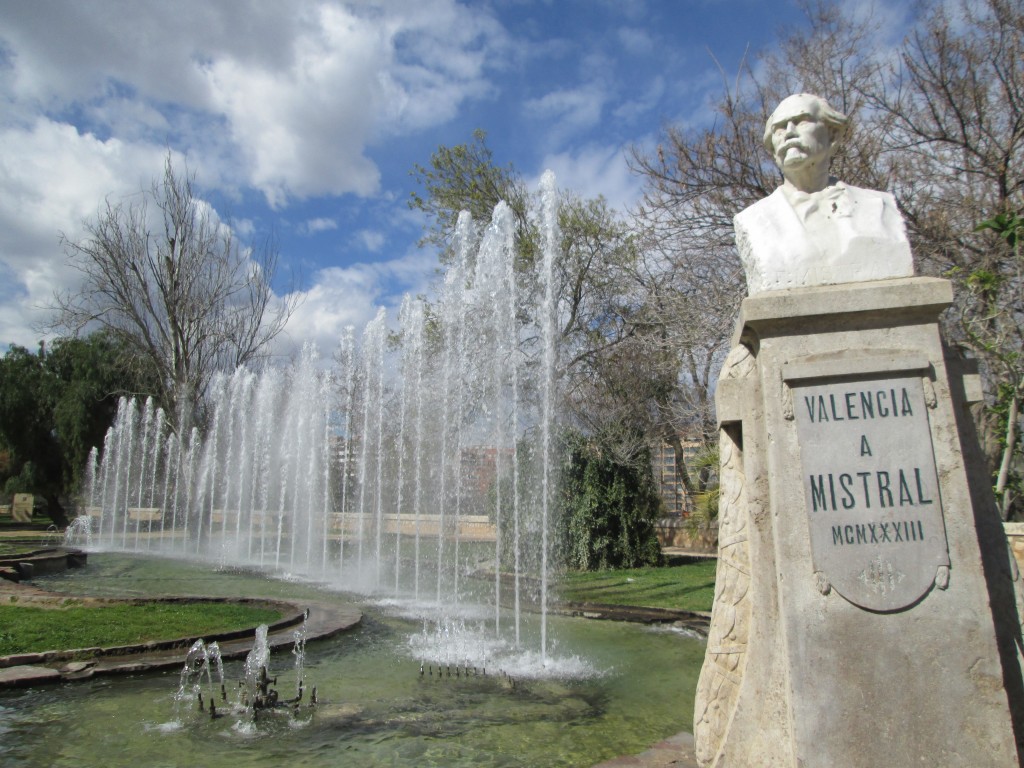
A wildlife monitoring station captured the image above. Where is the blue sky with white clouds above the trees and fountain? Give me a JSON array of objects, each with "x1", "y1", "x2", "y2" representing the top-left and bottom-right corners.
[{"x1": 0, "y1": 0, "x2": 815, "y2": 356}]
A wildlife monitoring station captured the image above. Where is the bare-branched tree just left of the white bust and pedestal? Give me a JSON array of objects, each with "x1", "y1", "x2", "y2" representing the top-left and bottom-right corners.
[{"x1": 630, "y1": 57, "x2": 777, "y2": 492}]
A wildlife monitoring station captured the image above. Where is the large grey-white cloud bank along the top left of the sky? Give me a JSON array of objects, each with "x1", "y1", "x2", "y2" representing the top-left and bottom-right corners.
[{"x1": 0, "y1": 0, "x2": 507, "y2": 207}]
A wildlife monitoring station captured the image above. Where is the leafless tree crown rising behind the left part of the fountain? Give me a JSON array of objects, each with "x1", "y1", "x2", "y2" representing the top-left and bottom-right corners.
[{"x1": 56, "y1": 156, "x2": 295, "y2": 435}]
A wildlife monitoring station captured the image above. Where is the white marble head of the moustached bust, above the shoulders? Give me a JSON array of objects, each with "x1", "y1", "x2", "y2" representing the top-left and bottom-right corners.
[{"x1": 763, "y1": 93, "x2": 850, "y2": 191}]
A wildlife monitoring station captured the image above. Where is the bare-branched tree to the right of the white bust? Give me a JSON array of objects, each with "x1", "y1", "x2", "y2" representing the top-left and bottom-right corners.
[{"x1": 766, "y1": 0, "x2": 1024, "y2": 517}]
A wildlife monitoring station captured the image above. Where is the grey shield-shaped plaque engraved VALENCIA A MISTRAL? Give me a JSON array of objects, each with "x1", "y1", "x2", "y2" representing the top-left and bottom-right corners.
[{"x1": 792, "y1": 375, "x2": 949, "y2": 611}]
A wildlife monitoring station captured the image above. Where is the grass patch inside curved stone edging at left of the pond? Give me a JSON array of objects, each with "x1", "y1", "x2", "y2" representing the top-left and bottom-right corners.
[{"x1": 0, "y1": 603, "x2": 281, "y2": 655}]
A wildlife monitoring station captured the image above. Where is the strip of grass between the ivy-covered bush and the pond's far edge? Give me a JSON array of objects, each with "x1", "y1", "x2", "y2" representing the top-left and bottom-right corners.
[{"x1": 558, "y1": 560, "x2": 716, "y2": 610}]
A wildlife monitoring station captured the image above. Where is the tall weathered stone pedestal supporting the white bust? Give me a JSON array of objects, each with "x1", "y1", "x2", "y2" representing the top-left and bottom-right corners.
[{"x1": 694, "y1": 278, "x2": 1024, "y2": 768}]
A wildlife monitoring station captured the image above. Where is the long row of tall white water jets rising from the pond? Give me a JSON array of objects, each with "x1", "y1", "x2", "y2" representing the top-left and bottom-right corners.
[{"x1": 75, "y1": 176, "x2": 558, "y2": 663}]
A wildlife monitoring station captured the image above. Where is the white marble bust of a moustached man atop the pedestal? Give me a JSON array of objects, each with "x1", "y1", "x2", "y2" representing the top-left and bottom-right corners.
[{"x1": 733, "y1": 93, "x2": 913, "y2": 295}]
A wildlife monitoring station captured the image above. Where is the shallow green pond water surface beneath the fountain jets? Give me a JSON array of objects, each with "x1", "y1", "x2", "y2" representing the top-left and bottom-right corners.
[{"x1": 0, "y1": 554, "x2": 703, "y2": 768}]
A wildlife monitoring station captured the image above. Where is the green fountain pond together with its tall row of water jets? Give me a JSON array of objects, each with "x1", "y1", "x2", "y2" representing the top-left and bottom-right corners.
[{"x1": 29, "y1": 179, "x2": 703, "y2": 768}]
